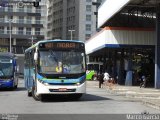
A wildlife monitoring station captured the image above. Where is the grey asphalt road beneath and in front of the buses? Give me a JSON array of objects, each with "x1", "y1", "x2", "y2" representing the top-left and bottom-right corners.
[{"x1": 0, "y1": 79, "x2": 160, "y2": 114}]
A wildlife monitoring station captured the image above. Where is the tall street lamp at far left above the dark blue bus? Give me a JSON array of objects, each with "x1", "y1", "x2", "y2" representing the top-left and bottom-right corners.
[{"x1": 6, "y1": 19, "x2": 15, "y2": 53}]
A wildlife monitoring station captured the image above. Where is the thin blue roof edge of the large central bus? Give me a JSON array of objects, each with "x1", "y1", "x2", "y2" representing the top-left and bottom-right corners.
[{"x1": 25, "y1": 39, "x2": 84, "y2": 52}]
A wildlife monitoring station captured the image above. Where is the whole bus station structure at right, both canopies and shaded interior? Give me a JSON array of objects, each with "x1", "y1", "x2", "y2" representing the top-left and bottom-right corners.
[{"x1": 86, "y1": 0, "x2": 160, "y2": 89}]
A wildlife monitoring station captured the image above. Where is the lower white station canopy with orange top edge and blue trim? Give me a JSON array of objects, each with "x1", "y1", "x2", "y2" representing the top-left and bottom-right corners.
[{"x1": 85, "y1": 27, "x2": 155, "y2": 54}]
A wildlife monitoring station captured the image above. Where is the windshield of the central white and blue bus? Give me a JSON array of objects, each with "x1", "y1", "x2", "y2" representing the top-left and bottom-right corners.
[{"x1": 39, "y1": 50, "x2": 85, "y2": 74}]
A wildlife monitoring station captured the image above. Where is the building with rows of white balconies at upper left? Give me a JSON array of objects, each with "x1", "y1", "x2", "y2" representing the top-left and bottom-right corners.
[{"x1": 0, "y1": 0, "x2": 47, "y2": 54}]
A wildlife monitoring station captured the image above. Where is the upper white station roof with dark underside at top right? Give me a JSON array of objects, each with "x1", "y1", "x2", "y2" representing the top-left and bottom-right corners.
[{"x1": 98, "y1": 0, "x2": 160, "y2": 28}]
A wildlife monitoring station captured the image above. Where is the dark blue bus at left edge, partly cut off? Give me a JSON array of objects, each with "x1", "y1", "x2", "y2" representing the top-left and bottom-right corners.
[{"x1": 0, "y1": 52, "x2": 18, "y2": 89}]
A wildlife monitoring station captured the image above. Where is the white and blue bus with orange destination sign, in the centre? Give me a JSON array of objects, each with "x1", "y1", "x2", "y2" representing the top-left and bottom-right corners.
[{"x1": 24, "y1": 40, "x2": 86, "y2": 100}]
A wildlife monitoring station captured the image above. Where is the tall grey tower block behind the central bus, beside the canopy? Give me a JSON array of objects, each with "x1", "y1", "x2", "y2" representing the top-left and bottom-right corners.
[{"x1": 47, "y1": 0, "x2": 101, "y2": 41}]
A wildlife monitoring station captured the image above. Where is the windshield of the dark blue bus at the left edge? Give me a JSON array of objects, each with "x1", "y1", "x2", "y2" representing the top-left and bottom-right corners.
[{"x1": 0, "y1": 57, "x2": 13, "y2": 78}]
